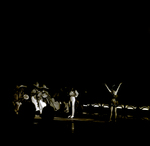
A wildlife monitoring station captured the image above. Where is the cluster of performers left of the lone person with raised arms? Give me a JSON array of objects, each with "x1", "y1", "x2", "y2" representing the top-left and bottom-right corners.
[{"x1": 13, "y1": 82, "x2": 79, "y2": 118}]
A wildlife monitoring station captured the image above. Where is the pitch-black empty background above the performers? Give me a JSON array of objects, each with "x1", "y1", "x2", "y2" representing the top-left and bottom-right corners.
[{"x1": 2, "y1": 5, "x2": 150, "y2": 104}]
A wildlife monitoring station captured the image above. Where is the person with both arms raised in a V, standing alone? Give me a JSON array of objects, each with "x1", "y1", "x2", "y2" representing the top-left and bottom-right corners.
[{"x1": 105, "y1": 83, "x2": 122, "y2": 122}]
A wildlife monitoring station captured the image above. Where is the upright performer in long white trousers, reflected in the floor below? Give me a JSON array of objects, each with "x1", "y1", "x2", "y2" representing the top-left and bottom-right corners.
[{"x1": 68, "y1": 88, "x2": 79, "y2": 118}]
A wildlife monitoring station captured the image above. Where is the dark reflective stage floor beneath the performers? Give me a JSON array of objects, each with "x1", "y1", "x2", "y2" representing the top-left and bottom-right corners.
[{"x1": 5, "y1": 115, "x2": 150, "y2": 145}]
